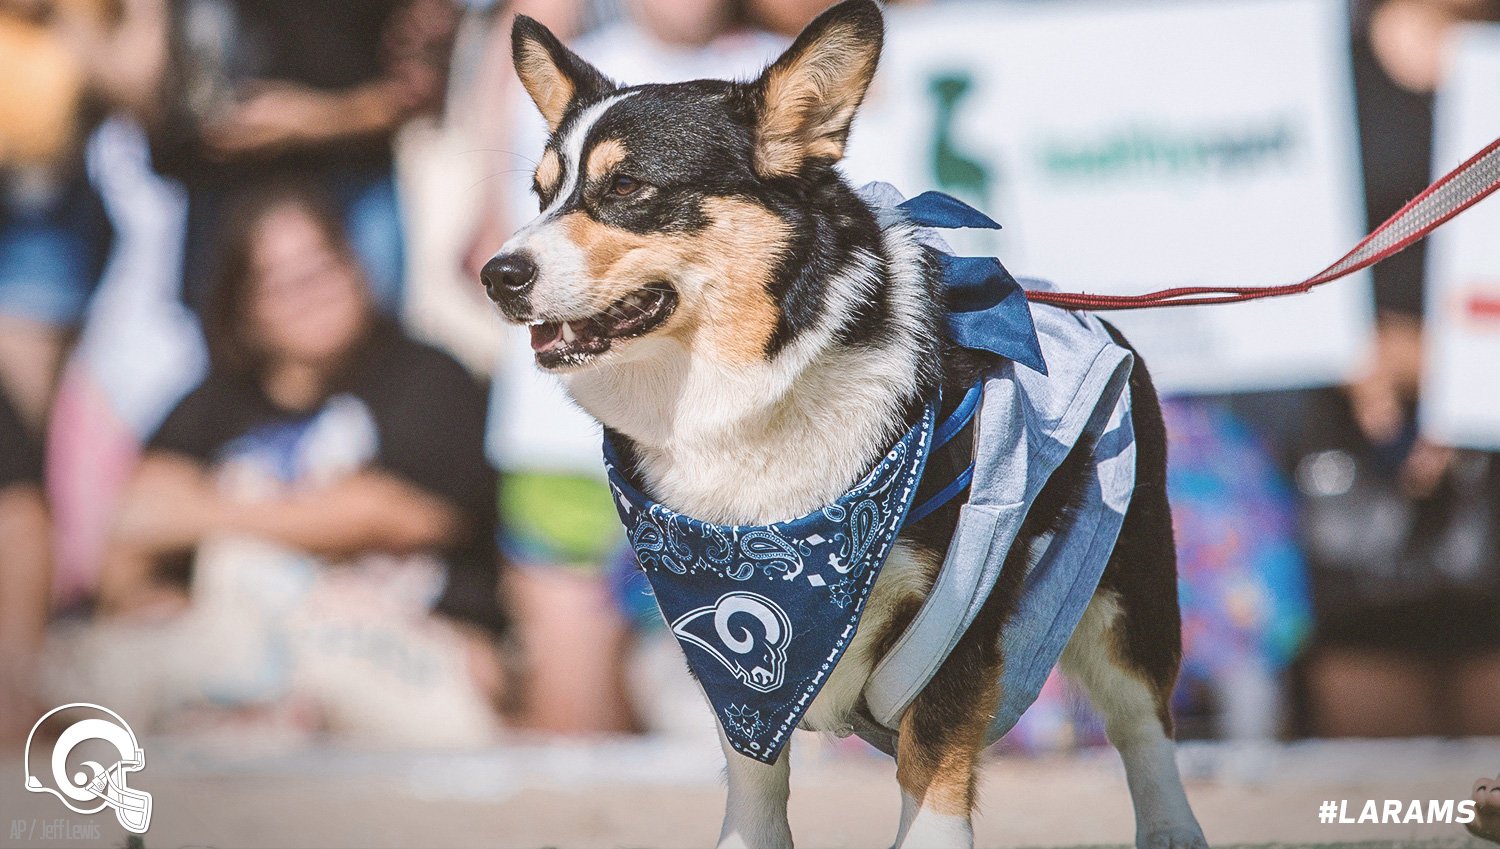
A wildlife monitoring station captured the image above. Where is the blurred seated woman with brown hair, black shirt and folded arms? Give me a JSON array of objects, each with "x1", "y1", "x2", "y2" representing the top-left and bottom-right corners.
[{"x1": 99, "y1": 185, "x2": 507, "y2": 741}]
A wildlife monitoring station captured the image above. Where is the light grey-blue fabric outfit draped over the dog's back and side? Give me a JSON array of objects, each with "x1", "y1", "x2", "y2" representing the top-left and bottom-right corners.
[{"x1": 854, "y1": 185, "x2": 1136, "y2": 752}]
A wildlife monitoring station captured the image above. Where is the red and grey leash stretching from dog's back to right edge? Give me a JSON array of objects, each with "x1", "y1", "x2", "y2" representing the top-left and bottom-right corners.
[{"x1": 1026, "y1": 138, "x2": 1500, "y2": 311}]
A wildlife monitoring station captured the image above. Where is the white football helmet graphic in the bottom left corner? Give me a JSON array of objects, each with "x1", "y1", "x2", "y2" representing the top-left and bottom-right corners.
[{"x1": 26, "y1": 702, "x2": 152, "y2": 834}]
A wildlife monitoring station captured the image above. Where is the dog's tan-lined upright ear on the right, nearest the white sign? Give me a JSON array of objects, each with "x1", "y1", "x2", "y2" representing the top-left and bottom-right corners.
[{"x1": 753, "y1": 0, "x2": 885, "y2": 177}]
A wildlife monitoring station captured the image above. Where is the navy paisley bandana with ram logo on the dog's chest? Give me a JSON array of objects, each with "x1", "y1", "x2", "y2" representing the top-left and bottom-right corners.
[{"x1": 605, "y1": 404, "x2": 938, "y2": 764}]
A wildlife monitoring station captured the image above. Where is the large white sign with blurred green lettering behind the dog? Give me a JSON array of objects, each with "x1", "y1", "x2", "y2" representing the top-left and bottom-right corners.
[{"x1": 846, "y1": 0, "x2": 1373, "y2": 393}]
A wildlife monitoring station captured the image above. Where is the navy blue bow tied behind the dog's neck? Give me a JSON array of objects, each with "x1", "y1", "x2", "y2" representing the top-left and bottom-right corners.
[{"x1": 896, "y1": 192, "x2": 1047, "y2": 375}]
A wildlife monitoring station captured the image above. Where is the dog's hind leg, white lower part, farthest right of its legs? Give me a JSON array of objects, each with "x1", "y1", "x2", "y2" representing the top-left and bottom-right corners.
[{"x1": 1062, "y1": 590, "x2": 1208, "y2": 849}]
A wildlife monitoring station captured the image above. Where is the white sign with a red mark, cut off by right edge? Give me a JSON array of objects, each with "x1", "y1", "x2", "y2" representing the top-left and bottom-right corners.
[{"x1": 1421, "y1": 26, "x2": 1500, "y2": 450}]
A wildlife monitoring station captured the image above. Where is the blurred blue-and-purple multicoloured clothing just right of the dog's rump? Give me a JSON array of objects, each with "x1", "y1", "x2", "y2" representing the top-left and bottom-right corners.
[{"x1": 1163, "y1": 396, "x2": 1313, "y2": 753}]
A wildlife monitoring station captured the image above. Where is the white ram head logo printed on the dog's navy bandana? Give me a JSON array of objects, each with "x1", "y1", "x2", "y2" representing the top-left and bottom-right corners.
[{"x1": 672, "y1": 593, "x2": 792, "y2": 693}]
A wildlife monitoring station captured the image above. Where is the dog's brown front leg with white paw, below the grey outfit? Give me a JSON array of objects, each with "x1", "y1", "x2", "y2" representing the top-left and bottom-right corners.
[{"x1": 896, "y1": 639, "x2": 1001, "y2": 849}]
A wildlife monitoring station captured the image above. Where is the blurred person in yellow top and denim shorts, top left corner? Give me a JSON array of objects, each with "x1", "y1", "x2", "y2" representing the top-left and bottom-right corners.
[{"x1": 0, "y1": 0, "x2": 165, "y2": 434}]
